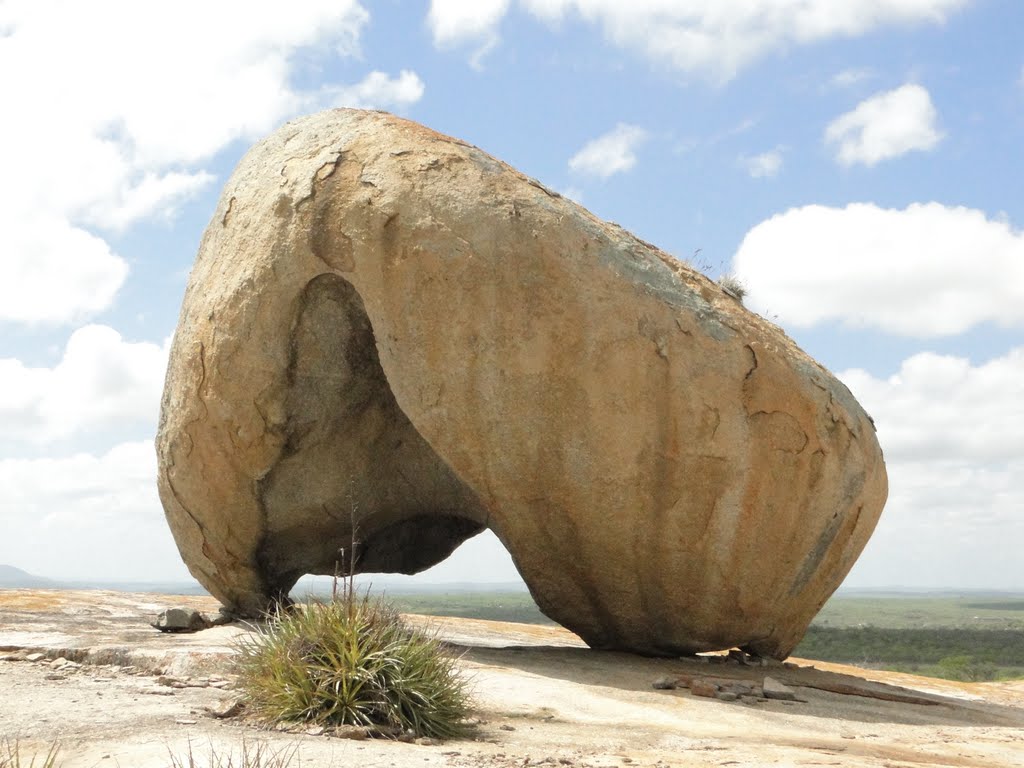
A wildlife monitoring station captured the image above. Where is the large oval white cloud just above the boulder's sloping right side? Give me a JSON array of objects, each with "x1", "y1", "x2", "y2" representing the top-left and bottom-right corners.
[{"x1": 733, "y1": 203, "x2": 1024, "y2": 338}]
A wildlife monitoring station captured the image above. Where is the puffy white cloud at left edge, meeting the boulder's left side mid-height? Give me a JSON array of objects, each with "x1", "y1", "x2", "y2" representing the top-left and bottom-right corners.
[{"x1": 0, "y1": 326, "x2": 168, "y2": 445}]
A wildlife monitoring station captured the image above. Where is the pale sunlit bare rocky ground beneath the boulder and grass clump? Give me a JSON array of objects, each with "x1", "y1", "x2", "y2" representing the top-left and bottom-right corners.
[{"x1": 0, "y1": 590, "x2": 1024, "y2": 768}]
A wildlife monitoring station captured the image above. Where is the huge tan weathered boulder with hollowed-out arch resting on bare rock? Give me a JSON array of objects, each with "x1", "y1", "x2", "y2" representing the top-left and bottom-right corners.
[{"x1": 157, "y1": 110, "x2": 886, "y2": 657}]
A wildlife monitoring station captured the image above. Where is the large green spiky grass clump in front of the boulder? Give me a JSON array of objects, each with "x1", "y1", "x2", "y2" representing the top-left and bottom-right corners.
[{"x1": 239, "y1": 591, "x2": 469, "y2": 738}]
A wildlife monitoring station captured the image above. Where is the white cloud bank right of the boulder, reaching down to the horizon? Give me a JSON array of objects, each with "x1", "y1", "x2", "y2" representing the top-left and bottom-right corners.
[{"x1": 839, "y1": 347, "x2": 1024, "y2": 588}]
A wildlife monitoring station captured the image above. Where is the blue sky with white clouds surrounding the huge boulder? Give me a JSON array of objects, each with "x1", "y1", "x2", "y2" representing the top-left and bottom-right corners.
[{"x1": 0, "y1": 0, "x2": 1024, "y2": 589}]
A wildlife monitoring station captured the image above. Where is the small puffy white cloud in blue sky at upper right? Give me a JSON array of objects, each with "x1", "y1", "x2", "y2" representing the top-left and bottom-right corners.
[{"x1": 825, "y1": 83, "x2": 942, "y2": 166}]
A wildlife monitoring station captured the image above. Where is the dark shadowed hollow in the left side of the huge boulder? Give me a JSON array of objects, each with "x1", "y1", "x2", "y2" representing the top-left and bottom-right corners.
[{"x1": 249, "y1": 272, "x2": 487, "y2": 606}]
